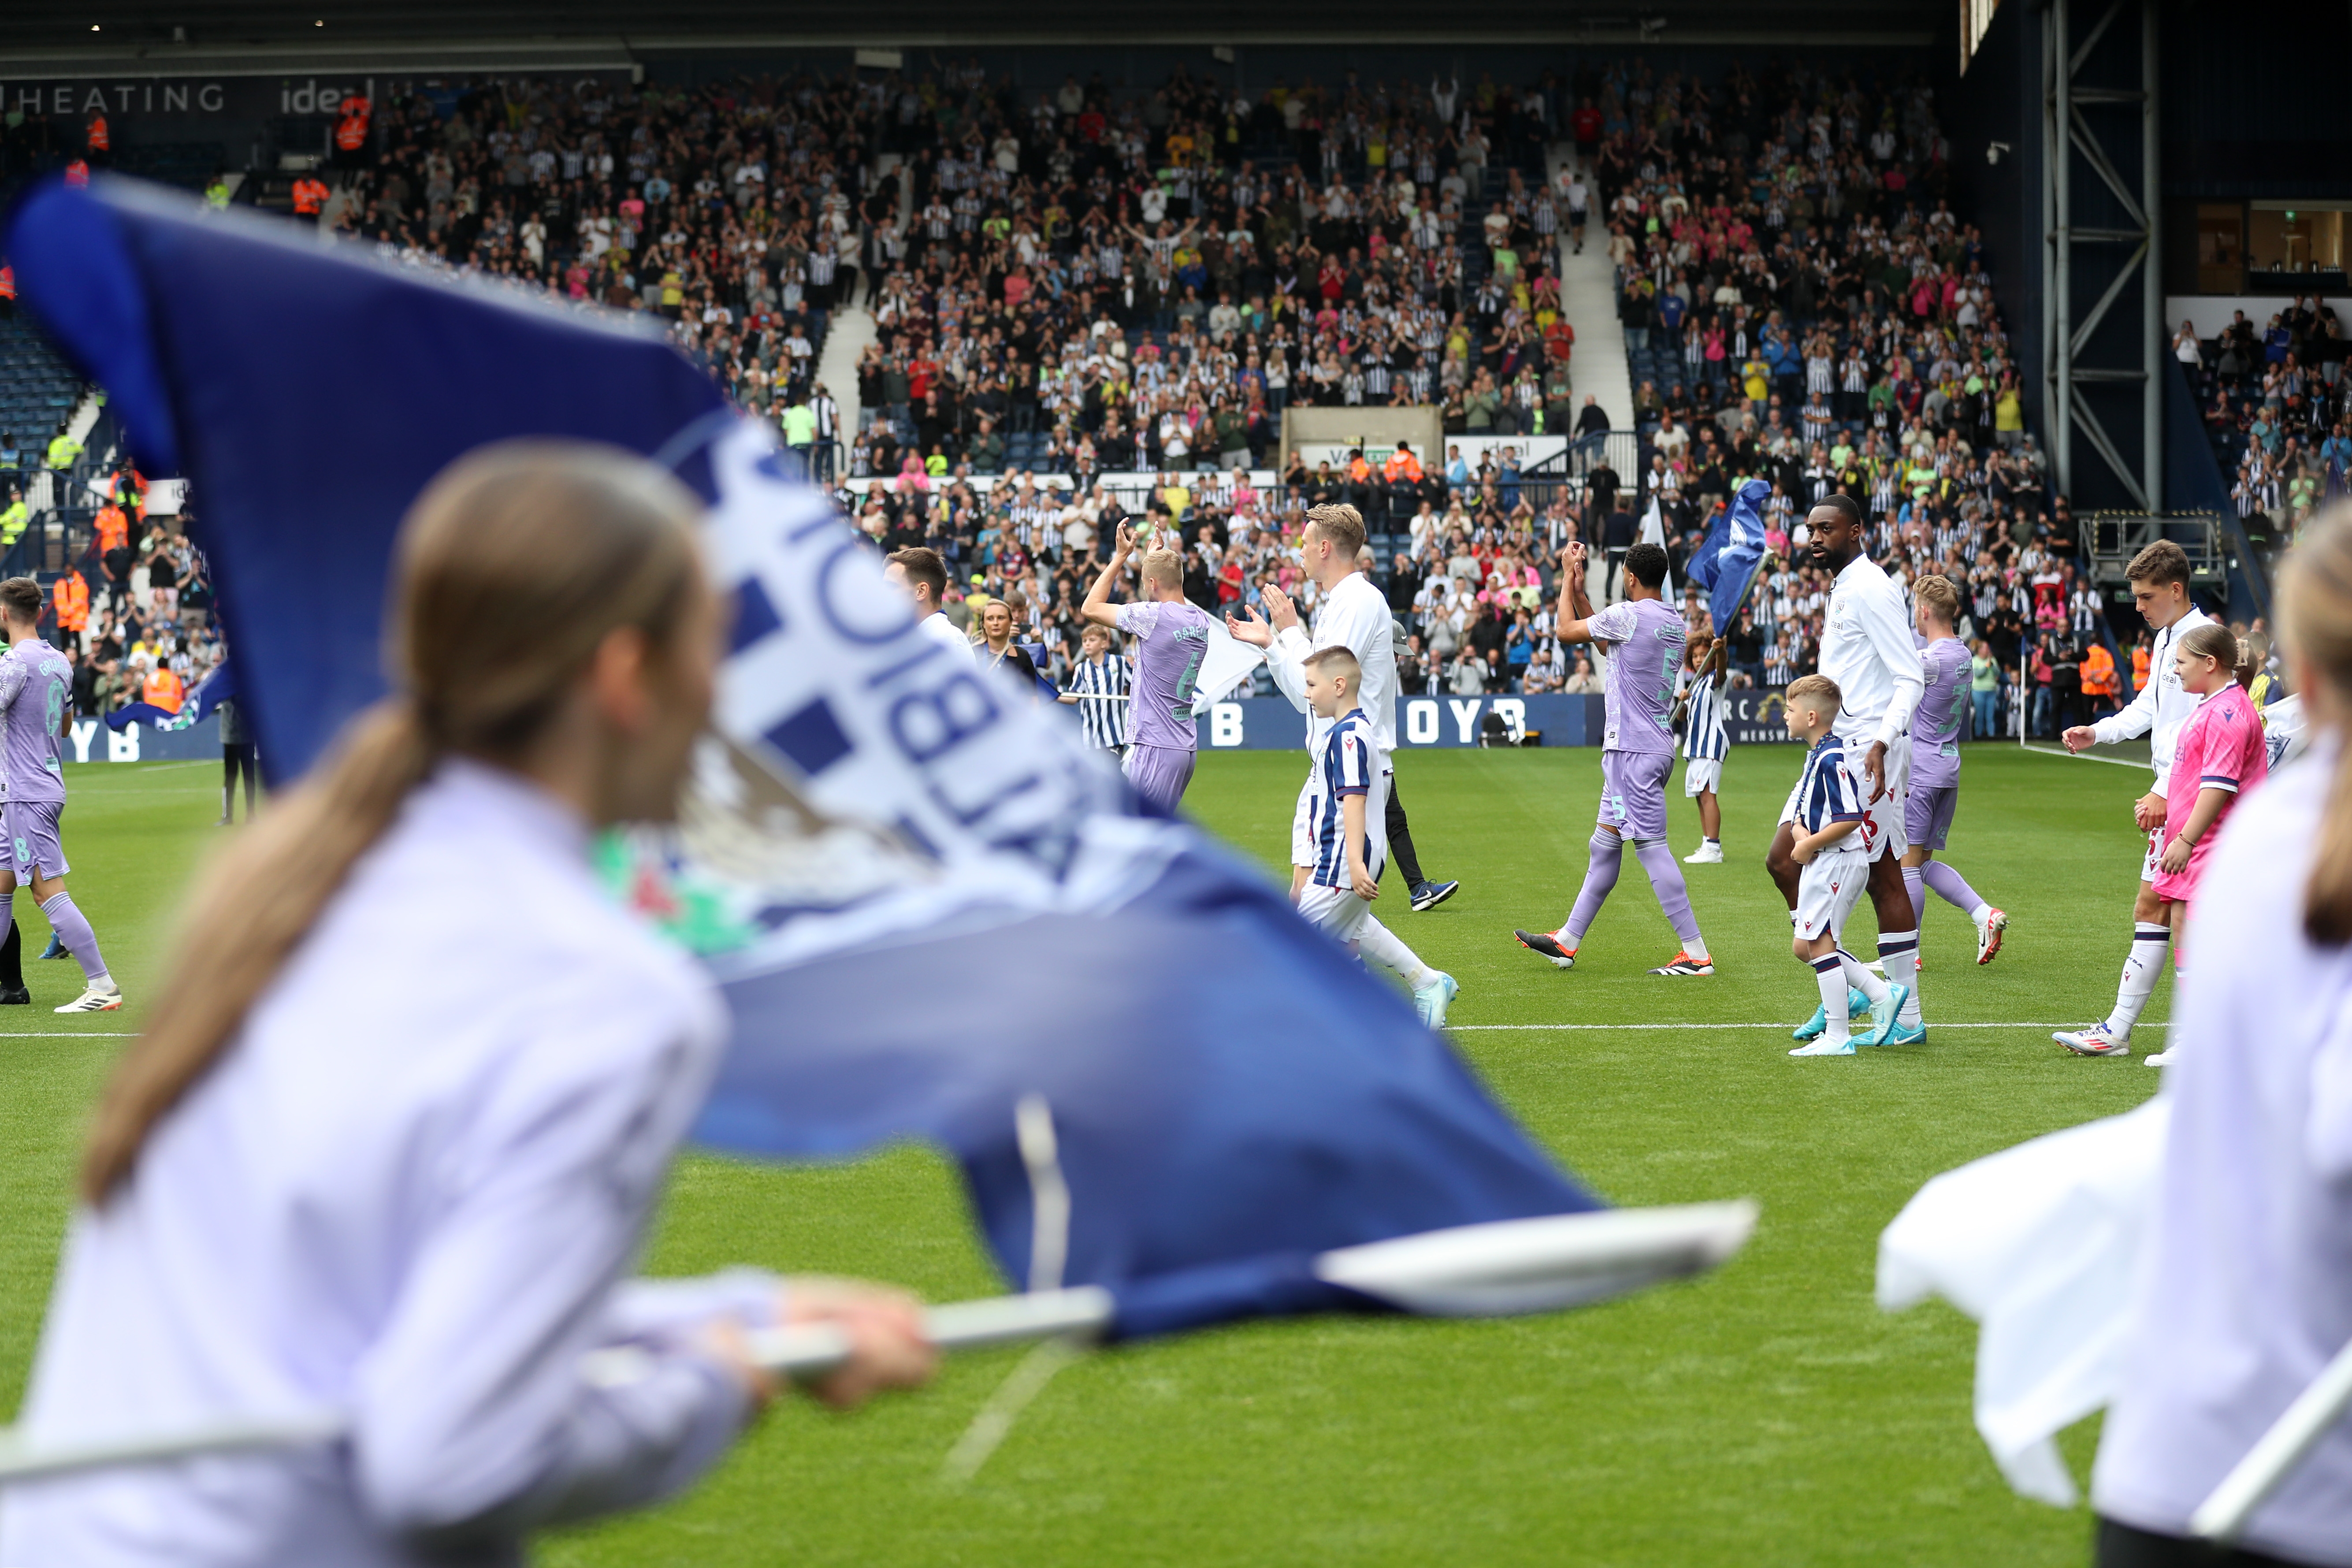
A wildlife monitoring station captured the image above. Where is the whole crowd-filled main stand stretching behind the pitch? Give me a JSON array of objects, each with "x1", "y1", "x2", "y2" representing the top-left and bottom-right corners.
[{"x1": 12, "y1": 54, "x2": 2103, "y2": 728}]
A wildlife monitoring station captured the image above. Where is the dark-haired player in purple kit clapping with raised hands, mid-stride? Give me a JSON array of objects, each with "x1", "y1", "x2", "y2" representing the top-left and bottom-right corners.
[{"x1": 1512, "y1": 543, "x2": 1715, "y2": 976}]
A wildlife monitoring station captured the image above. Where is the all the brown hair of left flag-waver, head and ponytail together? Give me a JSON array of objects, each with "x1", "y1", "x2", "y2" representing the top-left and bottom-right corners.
[{"x1": 82, "y1": 442, "x2": 701, "y2": 1206}]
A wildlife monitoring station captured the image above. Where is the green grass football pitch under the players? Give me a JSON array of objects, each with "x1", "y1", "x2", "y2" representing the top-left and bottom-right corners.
[{"x1": 0, "y1": 745, "x2": 2171, "y2": 1568}]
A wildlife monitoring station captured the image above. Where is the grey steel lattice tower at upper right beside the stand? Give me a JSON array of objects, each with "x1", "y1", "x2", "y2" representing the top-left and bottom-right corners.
[{"x1": 2042, "y1": 0, "x2": 2166, "y2": 513}]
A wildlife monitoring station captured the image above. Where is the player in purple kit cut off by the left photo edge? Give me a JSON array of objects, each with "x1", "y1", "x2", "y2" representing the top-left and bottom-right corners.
[{"x1": 0, "y1": 576, "x2": 123, "y2": 1013}]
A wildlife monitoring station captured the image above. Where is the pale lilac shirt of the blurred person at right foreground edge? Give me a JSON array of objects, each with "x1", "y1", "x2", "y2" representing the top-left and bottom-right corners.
[{"x1": 2091, "y1": 743, "x2": 2352, "y2": 1568}]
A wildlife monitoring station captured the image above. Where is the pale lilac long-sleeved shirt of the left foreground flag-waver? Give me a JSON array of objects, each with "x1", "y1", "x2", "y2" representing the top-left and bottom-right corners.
[{"x1": 0, "y1": 762, "x2": 776, "y2": 1568}]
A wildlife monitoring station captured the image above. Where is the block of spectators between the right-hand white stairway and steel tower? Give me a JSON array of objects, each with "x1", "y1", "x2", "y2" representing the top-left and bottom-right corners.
[{"x1": 1576, "y1": 63, "x2": 2100, "y2": 719}]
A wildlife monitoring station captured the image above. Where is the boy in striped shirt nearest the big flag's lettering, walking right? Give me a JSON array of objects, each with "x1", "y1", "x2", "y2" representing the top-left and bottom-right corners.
[{"x1": 1291, "y1": 647, "x2": 1453, "y2": 1029}]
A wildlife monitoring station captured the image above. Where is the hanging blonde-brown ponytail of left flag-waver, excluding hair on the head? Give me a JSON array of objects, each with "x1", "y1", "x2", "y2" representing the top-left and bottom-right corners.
[{"x1": 82, "y1": 698, "x2": 433, "y2": 1204}]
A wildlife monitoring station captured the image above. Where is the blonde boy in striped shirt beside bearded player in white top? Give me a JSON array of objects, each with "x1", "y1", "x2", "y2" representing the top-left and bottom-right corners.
[{"x1": 1783, "y1": 675, "x2": 1907, "y2": 1055}]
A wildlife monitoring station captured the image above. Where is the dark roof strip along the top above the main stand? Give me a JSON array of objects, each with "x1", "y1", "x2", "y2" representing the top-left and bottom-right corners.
[{"x1": 0, "y1": 0, "x2": 1952, "y2": 68}]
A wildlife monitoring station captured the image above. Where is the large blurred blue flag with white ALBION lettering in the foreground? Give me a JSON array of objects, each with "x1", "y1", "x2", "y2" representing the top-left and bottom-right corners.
[{"x1": 9, "y1": 178, "x2": 1752, "y2": 1335}]
